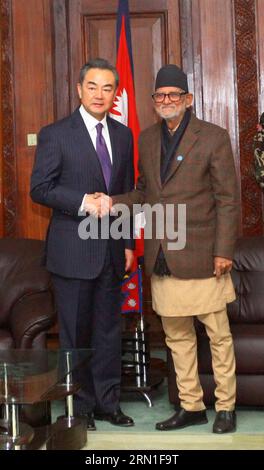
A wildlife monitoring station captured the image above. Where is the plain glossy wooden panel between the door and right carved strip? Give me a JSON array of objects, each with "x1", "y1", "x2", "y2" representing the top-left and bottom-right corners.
[{"x1": 180, "y1": 0, "x2": 240, "y2": 231}]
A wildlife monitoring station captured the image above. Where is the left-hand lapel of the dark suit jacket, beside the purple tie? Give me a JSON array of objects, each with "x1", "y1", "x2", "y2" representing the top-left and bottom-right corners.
[{"x1": 72, "y1": 109, "x2": 106, "y2": 189}]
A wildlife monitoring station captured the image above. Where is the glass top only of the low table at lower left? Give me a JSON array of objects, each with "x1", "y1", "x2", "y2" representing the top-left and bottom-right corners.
[{"x1": 0, "y1": 349, "x2": 92, "y2": 404}]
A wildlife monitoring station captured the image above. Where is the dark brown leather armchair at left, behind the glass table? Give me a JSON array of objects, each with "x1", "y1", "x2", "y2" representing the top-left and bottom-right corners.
[{"x1": 0, "y1": 238, "x2": 56, "y2": 426}]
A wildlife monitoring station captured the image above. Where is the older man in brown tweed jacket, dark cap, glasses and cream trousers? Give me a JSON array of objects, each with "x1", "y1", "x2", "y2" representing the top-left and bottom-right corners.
[{"x1": 94, "y1": 64, "x2": 239, "y2": 433}]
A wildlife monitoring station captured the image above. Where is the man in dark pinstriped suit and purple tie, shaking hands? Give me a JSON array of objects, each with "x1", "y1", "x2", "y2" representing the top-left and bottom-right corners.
[{"x1": 31, "y1": 59, "x2": 134, "y2": 430}]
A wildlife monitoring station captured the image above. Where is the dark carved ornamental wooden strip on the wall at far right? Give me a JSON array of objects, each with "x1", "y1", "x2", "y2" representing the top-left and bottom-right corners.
[{"x1": 234, "y1": 0, "x2": 263, "y2": 236}]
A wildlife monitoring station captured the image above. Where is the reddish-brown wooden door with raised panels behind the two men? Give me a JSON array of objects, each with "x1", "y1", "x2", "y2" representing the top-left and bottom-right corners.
[{"x1": 54, "y1": 0, "x2": 181, "y2": 129}]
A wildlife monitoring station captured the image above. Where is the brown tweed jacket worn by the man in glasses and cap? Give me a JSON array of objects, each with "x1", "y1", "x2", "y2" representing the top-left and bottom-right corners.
[{"x1": 113, "y1": 115, "x2": 239, "y2": 279}]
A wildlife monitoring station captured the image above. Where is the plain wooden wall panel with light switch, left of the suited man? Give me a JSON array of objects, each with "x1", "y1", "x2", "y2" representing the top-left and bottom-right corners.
[{"x1": 12, "y1": 0, "x2": 53, "y2": 238}]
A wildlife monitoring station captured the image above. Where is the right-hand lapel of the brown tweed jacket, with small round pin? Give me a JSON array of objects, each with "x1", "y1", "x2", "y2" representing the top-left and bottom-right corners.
[{"x1": 164, "y1": 115, "x2": 199, "y2": 184}]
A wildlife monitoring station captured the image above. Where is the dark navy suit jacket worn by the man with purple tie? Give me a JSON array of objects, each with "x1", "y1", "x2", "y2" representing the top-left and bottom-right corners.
[{"x1": 31, "y1": 109, "x2": 134, "y2": 279}]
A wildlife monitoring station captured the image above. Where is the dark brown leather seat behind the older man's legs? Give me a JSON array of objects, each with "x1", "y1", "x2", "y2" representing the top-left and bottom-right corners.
[{"x1": 168, "y1": 236, "x2": 264, "y2": 406}]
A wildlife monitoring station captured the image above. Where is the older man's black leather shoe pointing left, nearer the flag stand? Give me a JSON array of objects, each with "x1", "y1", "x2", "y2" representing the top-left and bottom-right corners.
[{"x1": 156, "y1": 408, "x2": 208, "y2": 431}]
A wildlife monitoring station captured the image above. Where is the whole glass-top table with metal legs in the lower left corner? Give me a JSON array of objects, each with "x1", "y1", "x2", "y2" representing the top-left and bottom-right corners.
[{"x1": 0, "y1": 349, "x2": 92, "y2": 449}]
